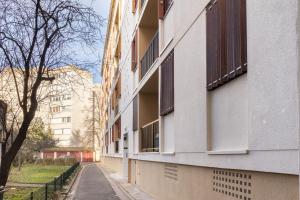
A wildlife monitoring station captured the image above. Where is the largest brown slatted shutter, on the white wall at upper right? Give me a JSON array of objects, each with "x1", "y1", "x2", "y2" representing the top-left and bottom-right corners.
[{"x1": 206, "y1": 0, "x2": 247, "y2": 91}]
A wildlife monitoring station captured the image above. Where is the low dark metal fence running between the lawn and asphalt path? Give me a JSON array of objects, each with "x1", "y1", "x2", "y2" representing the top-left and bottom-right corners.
[{"x1": 24, "y1": 162, "x2": 80, "y2": 200}]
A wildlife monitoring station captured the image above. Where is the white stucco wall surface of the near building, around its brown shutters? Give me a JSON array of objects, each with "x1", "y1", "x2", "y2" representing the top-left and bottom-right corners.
[{"x1": 103, "y1": 0, "x2": 299, "y2": 174}]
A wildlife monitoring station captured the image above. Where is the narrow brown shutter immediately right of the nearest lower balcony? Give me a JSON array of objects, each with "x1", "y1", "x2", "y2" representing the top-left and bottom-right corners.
[{"x1": 160, "y1": 50, "x2": 174, "y2": 116}]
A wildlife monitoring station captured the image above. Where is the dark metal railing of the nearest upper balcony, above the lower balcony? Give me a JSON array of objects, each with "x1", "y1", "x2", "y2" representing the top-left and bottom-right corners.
[{"x1": 141, "y1": 32, "x2": 159, "y2": 78}]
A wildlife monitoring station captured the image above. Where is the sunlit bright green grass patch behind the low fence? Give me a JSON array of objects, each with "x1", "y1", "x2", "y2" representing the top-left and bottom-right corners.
[{"x1": 8, "y1": 164, "x2": 70, "y2": 183}]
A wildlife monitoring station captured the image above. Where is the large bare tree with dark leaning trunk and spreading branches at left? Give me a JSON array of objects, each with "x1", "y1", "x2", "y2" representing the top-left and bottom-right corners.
[{"x1": 0, "y1": 0, "x2": 103, "y2": 195}]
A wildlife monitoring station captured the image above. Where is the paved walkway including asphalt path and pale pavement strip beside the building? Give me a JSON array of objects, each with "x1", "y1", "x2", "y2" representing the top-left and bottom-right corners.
[{"x1": 66, "y1": 163, "x2": 154, "y2": 200}]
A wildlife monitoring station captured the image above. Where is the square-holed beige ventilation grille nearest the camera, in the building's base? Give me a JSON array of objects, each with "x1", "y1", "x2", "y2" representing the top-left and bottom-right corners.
[{"x1": 212, "y1": 169, "x2": 253, "y2": 200}]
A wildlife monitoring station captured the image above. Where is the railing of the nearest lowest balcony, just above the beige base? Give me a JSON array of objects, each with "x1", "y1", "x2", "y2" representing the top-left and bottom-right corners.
[{"x1": 141, "y1": 120, "x2": 159, "y2": 152}]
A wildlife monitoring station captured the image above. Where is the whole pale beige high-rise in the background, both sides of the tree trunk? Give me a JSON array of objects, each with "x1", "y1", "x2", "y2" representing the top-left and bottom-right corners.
[{"x1": 1, "y1": 66, "x2": 95, "y2": 147}]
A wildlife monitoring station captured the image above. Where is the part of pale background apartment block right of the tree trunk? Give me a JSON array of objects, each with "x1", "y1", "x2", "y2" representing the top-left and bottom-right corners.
[{"x1": 37, "y1": 67, "x2": 93, "y2": 147}]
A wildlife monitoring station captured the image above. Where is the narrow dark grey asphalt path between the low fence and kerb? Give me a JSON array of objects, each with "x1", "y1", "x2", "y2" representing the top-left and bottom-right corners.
[{"x1": 72, "y1": 164, "x2": 120, "y2": 200}]
